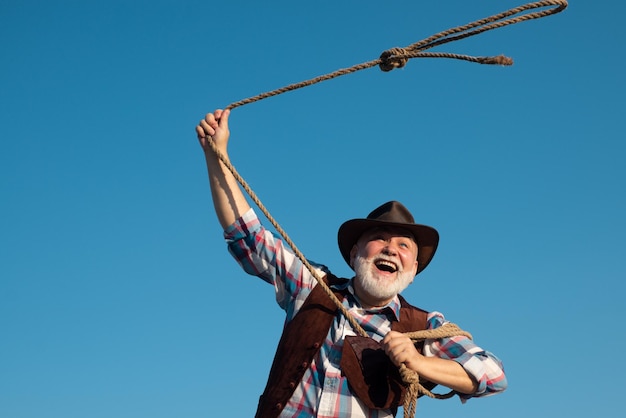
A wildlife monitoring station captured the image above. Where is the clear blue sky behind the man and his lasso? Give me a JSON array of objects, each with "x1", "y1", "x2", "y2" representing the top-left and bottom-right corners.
[{"x1": 0, "y1": 0, "x2": 626, "y2": 418}]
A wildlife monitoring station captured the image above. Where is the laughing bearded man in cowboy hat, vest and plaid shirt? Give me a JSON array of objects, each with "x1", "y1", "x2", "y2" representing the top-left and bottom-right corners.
[{"x1": 196, "y1": 110, "x2": 507, "y2": 417}]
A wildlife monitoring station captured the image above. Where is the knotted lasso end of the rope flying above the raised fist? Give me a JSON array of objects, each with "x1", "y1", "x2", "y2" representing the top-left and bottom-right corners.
[{"x1": 226, "y1": 0, "x2": 567, "y2": 109}]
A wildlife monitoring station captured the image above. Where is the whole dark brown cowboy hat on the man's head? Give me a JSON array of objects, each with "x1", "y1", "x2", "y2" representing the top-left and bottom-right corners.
[{"x1": 337, "y1": 201, "x2": 439, "y2": 274}]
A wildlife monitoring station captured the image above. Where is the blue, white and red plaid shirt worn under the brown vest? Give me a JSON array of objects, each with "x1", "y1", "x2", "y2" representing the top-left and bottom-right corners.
[{"x1": 224, "y1": 209, "x2": 507, "y2": 418}]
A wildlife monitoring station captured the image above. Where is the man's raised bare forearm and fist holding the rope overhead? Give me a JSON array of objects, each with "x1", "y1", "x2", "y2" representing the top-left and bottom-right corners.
[{"x1": 196, "y1": 109, "x2": 250, "y2": 229}]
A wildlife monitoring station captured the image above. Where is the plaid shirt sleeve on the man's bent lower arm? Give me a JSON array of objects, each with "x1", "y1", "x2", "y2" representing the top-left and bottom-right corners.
[{"x1": 424, "y1": 312, "x2": 507, "y2": 401}]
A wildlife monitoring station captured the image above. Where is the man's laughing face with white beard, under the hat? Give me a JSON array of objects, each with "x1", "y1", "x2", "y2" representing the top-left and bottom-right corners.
[{"x1": 350, "y1": 228, "x2": 418, "y2": 306}]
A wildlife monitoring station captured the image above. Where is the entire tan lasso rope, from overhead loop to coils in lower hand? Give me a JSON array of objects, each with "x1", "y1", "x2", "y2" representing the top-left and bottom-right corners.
[{"x1": 207, "y1": 0, "x2": 568, "y2": 418}]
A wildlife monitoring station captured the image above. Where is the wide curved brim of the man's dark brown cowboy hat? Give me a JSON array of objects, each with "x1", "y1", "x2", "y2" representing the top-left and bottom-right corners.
[{"x1": 337, "y1": 219, "x2": 439, "y2": 274}]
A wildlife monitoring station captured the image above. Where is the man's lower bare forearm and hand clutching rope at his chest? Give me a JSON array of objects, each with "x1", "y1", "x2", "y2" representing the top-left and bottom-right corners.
[{"x1": 382, "y1": 331, "x2": 478, "y2": 395}]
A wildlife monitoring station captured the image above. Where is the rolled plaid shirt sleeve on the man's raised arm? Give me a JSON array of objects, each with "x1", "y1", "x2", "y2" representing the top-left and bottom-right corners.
[{"x1": 224, "y1": 208, "x2": 327, "y2": 317}]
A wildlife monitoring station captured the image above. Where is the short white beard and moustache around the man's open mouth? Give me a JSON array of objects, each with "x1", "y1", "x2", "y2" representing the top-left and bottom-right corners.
[{"x1": 354, "y1": 255, "x2": 413, "y2": 300}]
